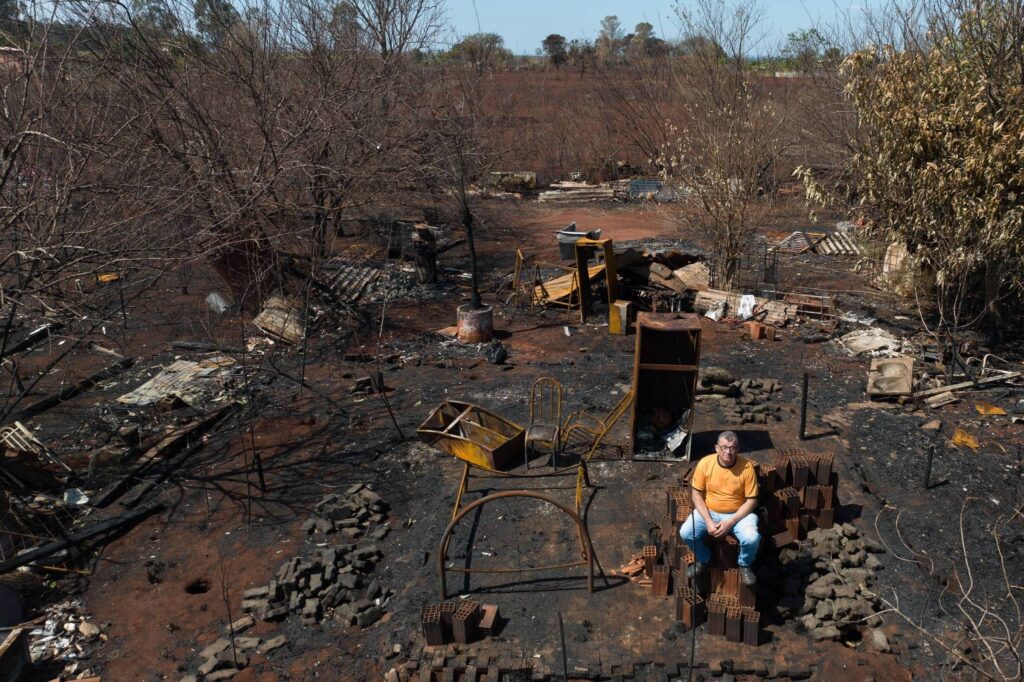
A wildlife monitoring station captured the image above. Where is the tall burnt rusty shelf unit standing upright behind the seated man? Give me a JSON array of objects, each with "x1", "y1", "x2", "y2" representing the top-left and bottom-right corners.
[{"x1": 630, "y1": 312, "x2": 700, "y2": 458}]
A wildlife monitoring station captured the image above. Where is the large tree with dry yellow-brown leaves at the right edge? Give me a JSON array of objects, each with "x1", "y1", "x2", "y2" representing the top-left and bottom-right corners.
[{"x1": 798, "y1": 0, "x2": 1024, "y2": 337}]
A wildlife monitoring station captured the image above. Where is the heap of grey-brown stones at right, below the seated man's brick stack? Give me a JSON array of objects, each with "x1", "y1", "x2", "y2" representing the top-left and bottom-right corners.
[{"x1": 764, "y1": 523, "x2": 885, "y2": 641}]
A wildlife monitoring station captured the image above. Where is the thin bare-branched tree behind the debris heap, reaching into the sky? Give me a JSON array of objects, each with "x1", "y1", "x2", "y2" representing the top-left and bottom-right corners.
[{"x1": 660, "y1": 0, "x2": 792, "y2": 288}]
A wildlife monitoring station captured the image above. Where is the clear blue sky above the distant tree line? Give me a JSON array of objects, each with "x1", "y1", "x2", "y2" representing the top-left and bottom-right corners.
[{"x1": 447, "y1": 0, "x2": 865, "y2": 54}]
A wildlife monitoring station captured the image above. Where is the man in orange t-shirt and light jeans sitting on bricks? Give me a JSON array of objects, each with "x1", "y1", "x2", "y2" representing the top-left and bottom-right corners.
[{"x1": 679, "y1": 431, "x2": 761, "y2": 586}]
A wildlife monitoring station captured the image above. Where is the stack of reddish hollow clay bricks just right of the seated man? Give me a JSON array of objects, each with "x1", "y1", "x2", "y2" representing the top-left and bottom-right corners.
[{"x1": 758, "y1": 450, "x2": 839, "y2": 549}]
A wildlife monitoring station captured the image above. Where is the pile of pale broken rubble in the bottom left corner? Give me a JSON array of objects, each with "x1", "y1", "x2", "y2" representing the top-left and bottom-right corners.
[{"x1": 29, "y1": 599, "x2": 106, "y2": 677}]
